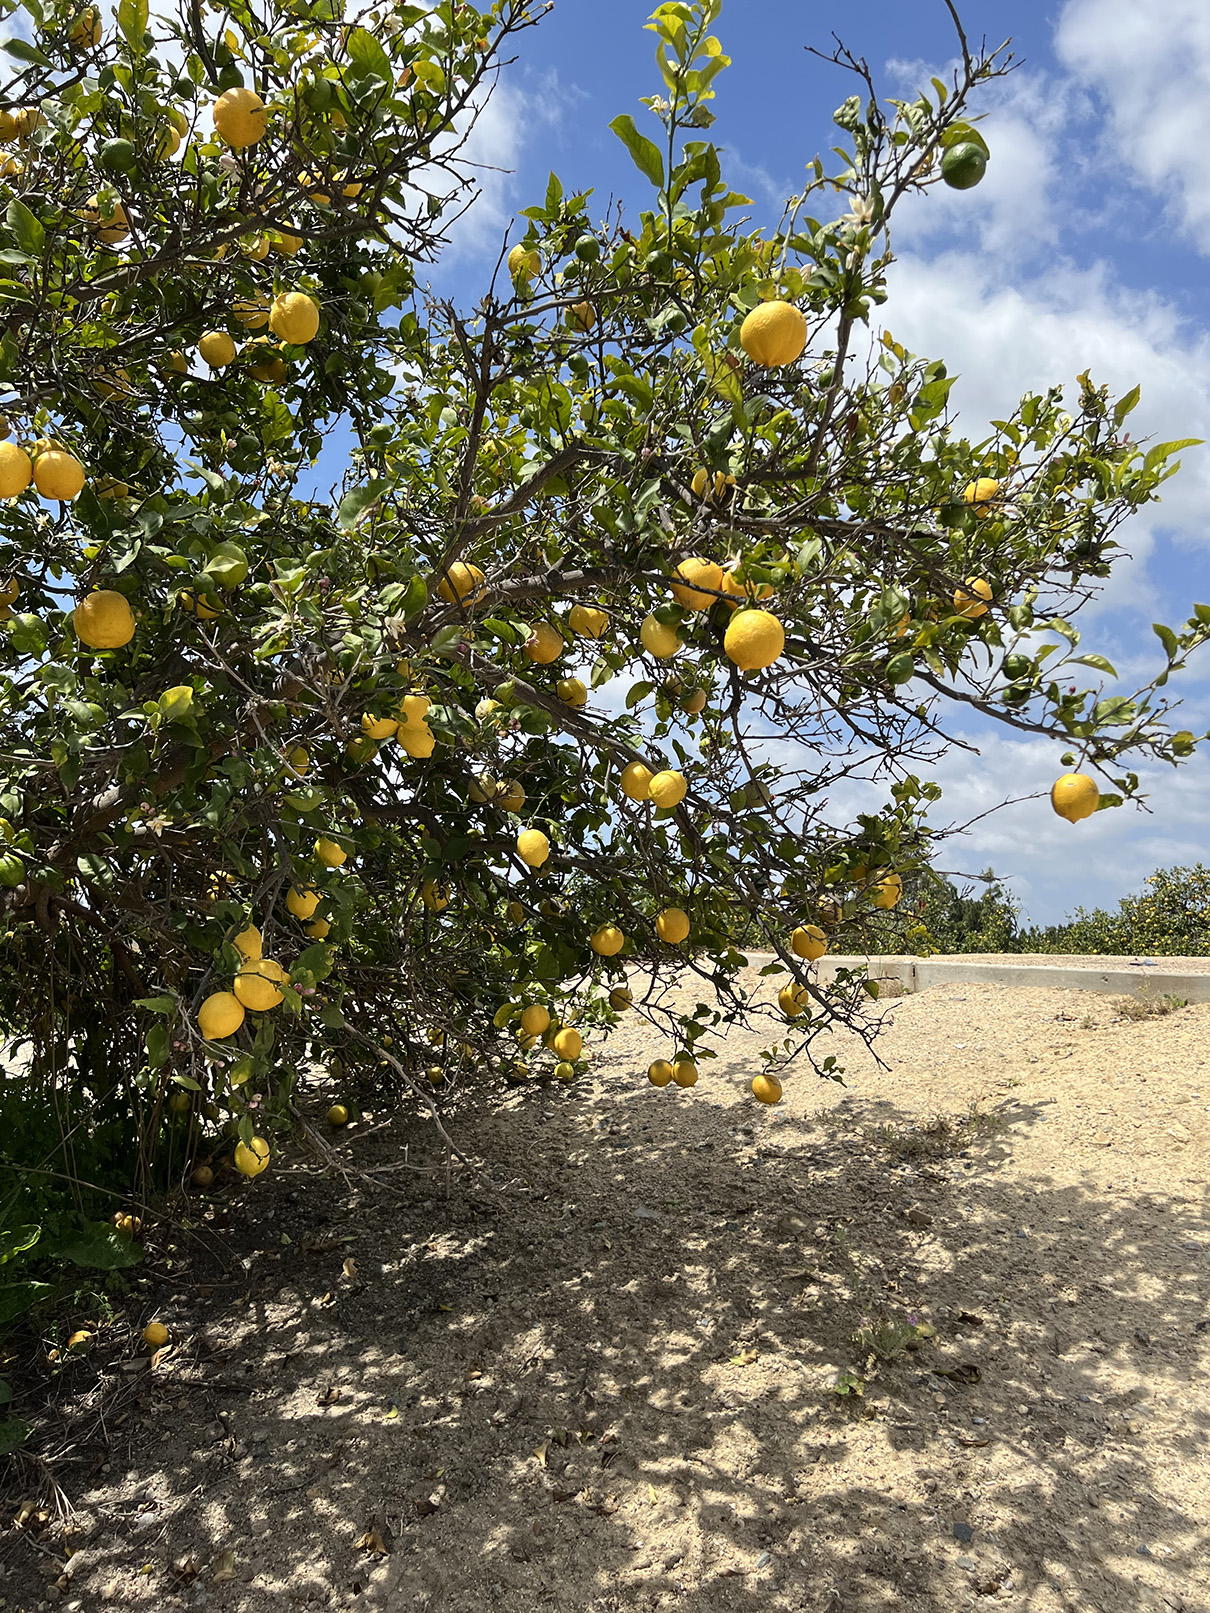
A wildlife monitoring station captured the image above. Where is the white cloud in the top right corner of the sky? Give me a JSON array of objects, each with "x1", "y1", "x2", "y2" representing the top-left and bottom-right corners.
[{"x1": 1055, "y1": 0, "x2": 1210, "y2": 252}]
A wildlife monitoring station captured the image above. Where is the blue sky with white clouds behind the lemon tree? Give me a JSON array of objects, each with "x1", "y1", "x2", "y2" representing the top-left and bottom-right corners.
[{"x1": 419, "y1": 0, "x2": 1210, "y2": 923}]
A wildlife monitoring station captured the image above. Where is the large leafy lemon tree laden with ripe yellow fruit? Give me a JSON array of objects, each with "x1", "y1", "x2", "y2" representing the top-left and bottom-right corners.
[{"x1": 0, "y1": 0, "x2": 1210, "y2": 1206}]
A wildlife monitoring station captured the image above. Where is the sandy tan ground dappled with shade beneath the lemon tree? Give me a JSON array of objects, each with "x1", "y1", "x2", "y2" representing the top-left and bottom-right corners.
[{"x1": 0, "y1": 977, "x2": 1210, "y2": 1613}]
